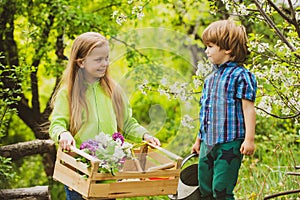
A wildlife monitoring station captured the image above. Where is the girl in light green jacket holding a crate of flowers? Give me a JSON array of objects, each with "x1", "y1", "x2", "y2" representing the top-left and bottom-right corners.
[{"x1": 49, "y1": 32, "x2": 160, "y2": 199}]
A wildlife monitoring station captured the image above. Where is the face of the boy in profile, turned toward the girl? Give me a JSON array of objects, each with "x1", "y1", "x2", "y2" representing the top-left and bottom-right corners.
[{"x1": 205, "y1": 43, "x2": 230, "y2": 65}]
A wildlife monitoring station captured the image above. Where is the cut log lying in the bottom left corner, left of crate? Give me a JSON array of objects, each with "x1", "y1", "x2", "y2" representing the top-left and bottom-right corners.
[{"x1": 0, "y1": 186, "x2": 51, "y2": 200}]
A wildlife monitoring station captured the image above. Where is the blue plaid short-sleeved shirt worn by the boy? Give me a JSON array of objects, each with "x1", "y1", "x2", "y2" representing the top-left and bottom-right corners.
[{"x1": 198, "y1": 62, "x2": 257, "y2": 145}]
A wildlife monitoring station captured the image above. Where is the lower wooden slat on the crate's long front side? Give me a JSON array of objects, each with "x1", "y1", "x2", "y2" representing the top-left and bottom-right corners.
[{"x1": 89, "y1": 179, "x2": 178, "y2": 198}]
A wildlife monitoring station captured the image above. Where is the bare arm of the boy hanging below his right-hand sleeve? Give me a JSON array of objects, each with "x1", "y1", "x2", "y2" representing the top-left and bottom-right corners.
[{"x1": 240, "y1": 99, "x2": 256, "y2": 155}]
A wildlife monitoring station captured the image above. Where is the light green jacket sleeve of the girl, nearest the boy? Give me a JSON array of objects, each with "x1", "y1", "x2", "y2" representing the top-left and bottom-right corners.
[{"x1": 123, "y1": 98, "x2": 148, "y2": 142}]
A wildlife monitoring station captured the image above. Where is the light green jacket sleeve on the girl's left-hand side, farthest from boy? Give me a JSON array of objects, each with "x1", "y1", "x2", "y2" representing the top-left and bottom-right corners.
[{"x1": 49, "y1": 90, "x2": 70, "y2": 142}]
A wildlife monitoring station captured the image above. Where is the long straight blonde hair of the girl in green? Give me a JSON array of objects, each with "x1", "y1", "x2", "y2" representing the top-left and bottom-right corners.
[{"x1": 52, "y1": 32, "x2": 124, "y2": 136}]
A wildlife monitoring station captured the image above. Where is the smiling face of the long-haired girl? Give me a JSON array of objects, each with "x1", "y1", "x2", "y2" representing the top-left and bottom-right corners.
[{"x1": 81, "y1": 45, "x2": 109, "y2": 83}]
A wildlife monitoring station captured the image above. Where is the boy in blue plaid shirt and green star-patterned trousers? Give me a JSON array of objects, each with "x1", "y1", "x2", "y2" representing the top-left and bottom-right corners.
[{"x1": 192, "y1": 20, "x2": 257, "y2": 199}]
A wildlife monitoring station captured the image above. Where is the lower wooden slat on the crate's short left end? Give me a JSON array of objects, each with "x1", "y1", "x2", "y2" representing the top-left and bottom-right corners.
[{"x1": 53, "y1": 161, "x2": 90, "y2": 196}]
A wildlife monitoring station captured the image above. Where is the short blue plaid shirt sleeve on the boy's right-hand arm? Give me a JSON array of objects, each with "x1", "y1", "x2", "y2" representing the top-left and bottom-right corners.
[{"x1": 236, "y1": 71, "x2": 257, "y2": 102}]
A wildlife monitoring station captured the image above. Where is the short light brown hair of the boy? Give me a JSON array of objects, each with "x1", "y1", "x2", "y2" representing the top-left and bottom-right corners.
[{"x1": 202, "y1": 20, "x2": 248, "y2": 63}]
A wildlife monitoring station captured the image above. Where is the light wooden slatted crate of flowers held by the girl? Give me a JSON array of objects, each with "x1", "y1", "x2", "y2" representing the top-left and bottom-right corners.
[{"x1": 53, "y1": 144, "x2": 182, "y2": 199}]
